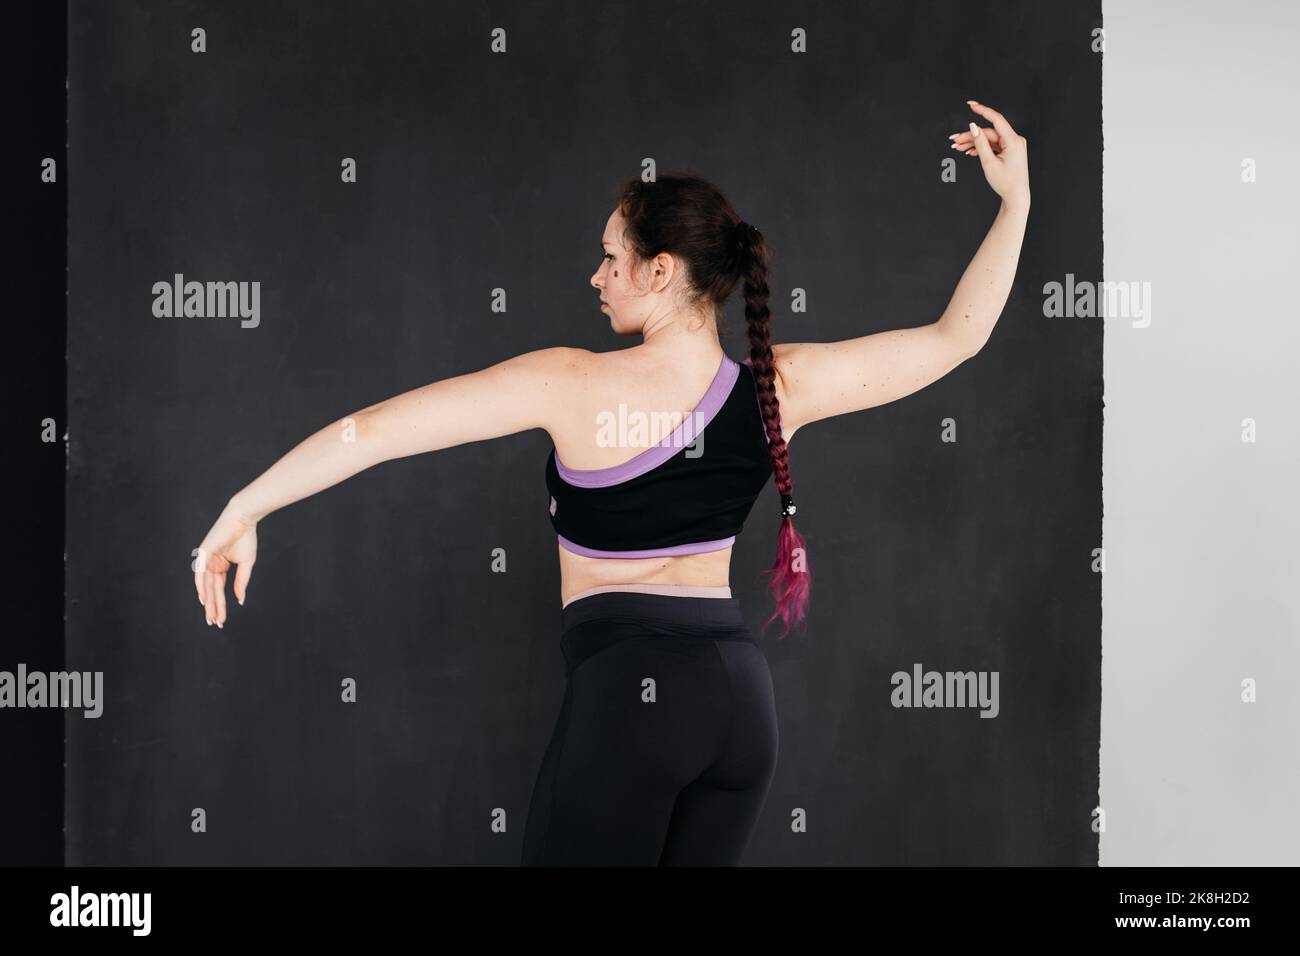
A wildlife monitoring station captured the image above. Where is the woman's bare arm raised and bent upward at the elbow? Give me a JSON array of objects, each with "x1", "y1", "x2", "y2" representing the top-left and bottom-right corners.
[{"x1": 772, "y1": 103, "x2": 1030, "y2": 436}]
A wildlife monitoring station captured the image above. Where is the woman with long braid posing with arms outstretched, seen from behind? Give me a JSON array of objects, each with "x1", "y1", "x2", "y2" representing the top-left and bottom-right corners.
[{"x1": 194, "y1": 101, "x2": 1030, "y2": 865}]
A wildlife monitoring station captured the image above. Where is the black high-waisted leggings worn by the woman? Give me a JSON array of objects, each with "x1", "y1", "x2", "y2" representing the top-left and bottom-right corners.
[{"x1": 523, "y1": 591, "x2": 777, "y2": 866}]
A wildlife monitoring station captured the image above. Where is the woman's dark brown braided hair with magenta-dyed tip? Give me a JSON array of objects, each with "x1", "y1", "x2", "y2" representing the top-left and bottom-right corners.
[{"x1": 618, "y1": 173, "x2": 813, "y2": 639}]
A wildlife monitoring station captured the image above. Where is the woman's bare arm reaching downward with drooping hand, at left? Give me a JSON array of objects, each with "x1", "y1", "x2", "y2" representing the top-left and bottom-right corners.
[{"x1": 194, "y1": 349, "x2": 582, "y2": 627}]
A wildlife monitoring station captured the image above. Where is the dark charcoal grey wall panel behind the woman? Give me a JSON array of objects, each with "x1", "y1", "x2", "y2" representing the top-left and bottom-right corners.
[{"x1": 66, "y1": 1, "x2": 1101, "y2": 865}]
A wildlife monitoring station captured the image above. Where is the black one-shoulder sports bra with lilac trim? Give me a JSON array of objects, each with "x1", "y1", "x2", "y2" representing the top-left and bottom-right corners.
[{"x1": 546, "y1": 355, "x2": 772, "y2": 558}]
